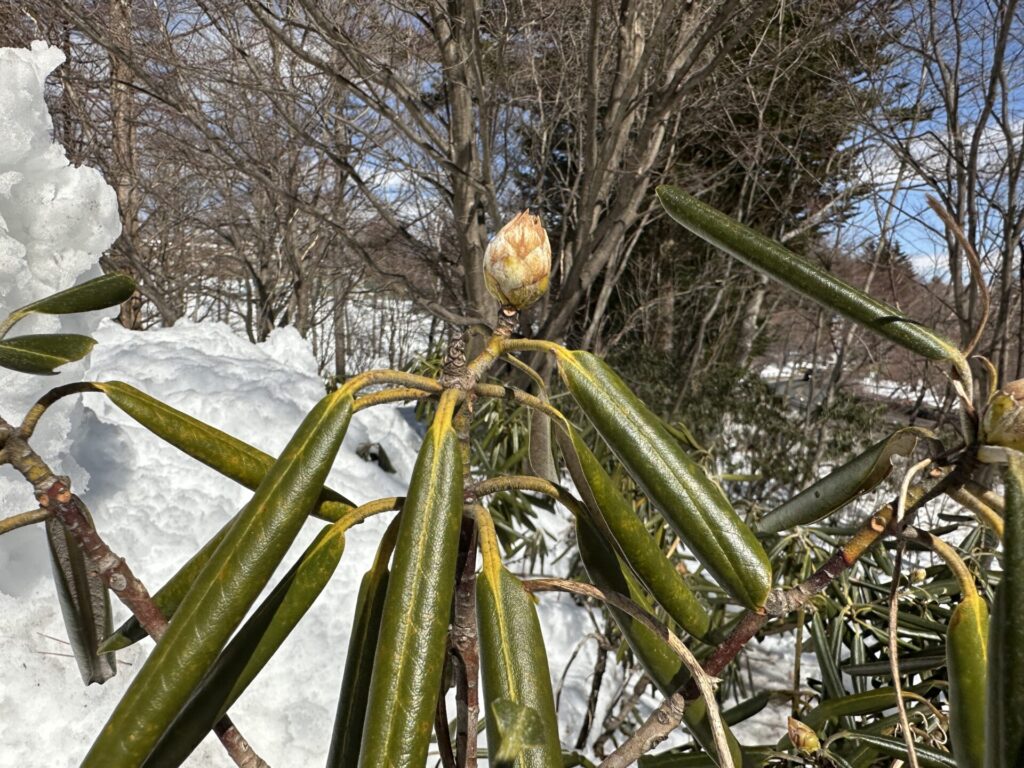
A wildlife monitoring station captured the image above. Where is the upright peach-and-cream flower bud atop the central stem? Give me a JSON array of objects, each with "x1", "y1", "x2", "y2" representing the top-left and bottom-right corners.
[{"x1": 483, "y1": 211, "x2": 551, "y2": 309}]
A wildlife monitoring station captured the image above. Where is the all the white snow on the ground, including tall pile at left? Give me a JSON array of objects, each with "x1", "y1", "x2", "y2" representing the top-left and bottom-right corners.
[{"x1": 0, "y1": 44, "x2": 792, "y2": 768}]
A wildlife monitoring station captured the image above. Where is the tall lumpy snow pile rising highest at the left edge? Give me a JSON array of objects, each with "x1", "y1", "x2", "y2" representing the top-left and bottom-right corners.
[{"x1": 0, "y1": 43, "x2": 121, "y2": 524}]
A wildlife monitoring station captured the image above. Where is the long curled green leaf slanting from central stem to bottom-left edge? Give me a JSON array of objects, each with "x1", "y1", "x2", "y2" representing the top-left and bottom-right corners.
[{"x1": 82, "y1": 389, "x2": 352, "y2": 768}]
